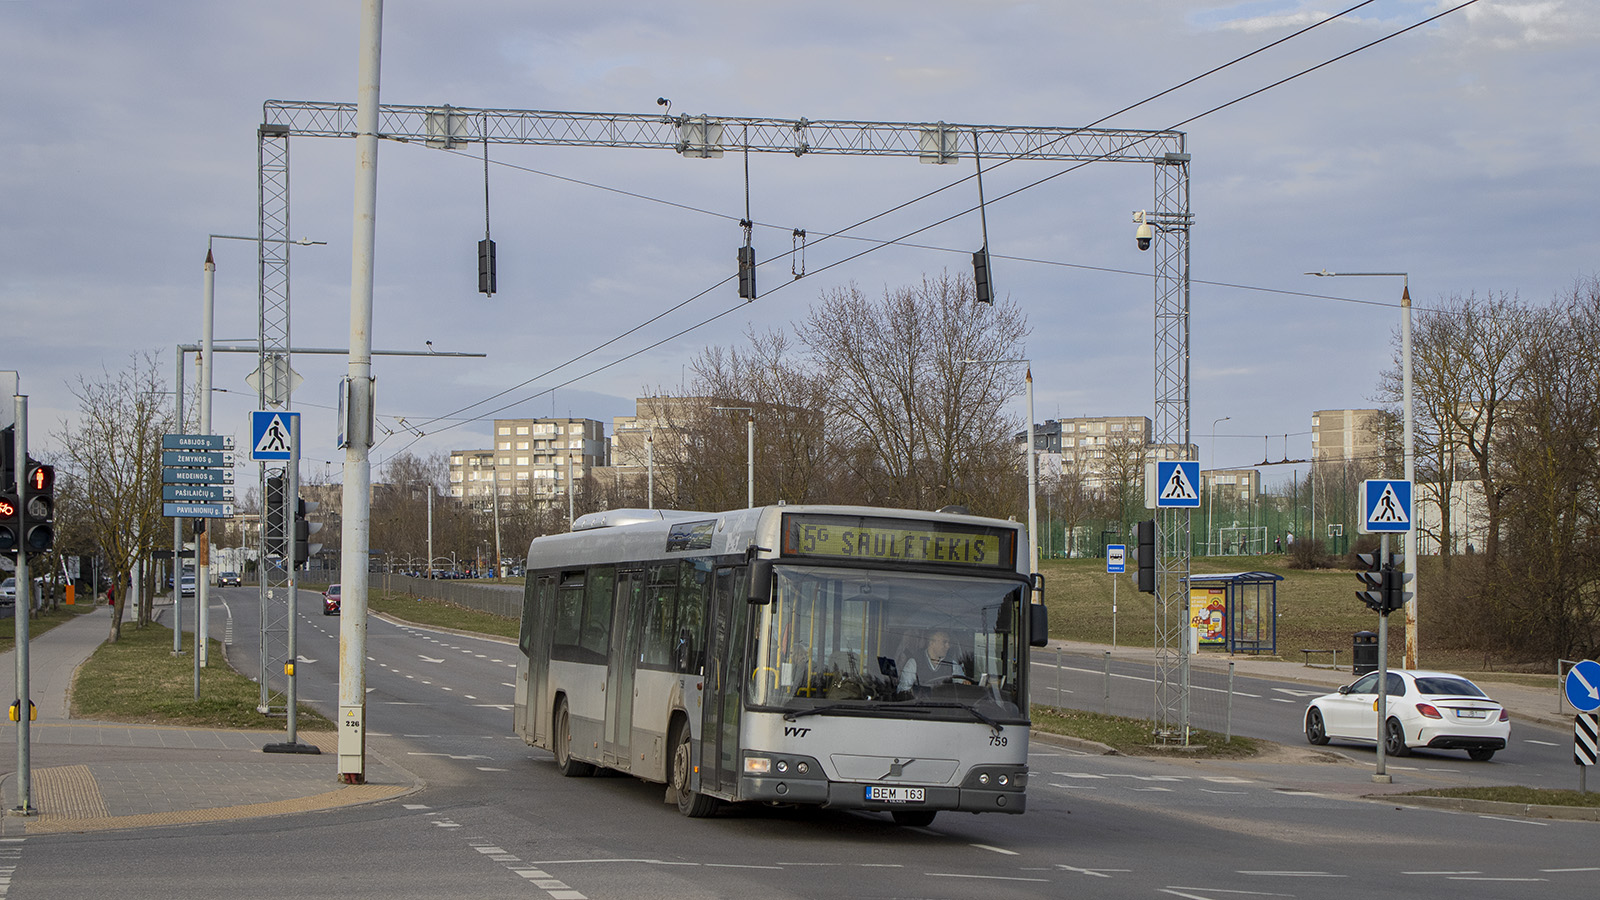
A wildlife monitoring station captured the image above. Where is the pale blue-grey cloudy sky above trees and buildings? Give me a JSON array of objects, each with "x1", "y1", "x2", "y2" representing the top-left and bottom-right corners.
[{"x1": 0, "y1": 0, "x2": 1600, "y2": 484}]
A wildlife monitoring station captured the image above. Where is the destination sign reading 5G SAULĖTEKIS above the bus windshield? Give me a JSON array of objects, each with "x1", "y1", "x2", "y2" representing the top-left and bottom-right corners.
[{"x1": 782, "y1": 516, "x2": 1016, "y2": 569}]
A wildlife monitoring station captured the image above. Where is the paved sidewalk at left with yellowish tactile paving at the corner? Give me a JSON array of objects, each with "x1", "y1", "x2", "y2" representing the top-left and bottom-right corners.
[{"x1": 0, "y1": 607, "x2": 421, "y2": 836}]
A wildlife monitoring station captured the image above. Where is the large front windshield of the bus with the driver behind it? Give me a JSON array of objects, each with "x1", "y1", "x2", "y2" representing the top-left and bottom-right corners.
[{"x1": 750, "y1": 565, "x2": 1022, "y2": 716}]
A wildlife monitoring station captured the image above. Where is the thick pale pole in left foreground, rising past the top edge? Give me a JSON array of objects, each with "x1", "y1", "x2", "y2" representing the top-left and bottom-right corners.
[{"x1": 338, "y1": 0, "x2": 379, "y2": 785}]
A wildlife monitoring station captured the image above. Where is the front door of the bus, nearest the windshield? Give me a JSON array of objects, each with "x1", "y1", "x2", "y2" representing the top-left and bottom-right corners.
[{"x1": 701, "y1": 567, "x2": 750, "y2": 796}]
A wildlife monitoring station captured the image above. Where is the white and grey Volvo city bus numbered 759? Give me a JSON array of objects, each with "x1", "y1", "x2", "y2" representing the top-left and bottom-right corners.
[{"x1": 514, "y1": 506, "x2": 1046, "y2": 825}]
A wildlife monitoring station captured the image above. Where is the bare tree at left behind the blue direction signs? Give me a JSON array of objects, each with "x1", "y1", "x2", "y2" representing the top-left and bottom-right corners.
[{"x1": 56, "y1": 354, "x2": 178, "y2": 641}]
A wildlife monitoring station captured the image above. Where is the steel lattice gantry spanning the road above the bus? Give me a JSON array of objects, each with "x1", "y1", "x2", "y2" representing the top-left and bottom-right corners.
[{"x1": 258, "y1": 99, "x2": 1192, "y2": 735}]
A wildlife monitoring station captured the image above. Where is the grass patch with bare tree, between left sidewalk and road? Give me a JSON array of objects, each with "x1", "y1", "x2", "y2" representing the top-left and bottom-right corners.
[{"x1": 72, "y1": 623, "x2": 334, "y2": 732}]
